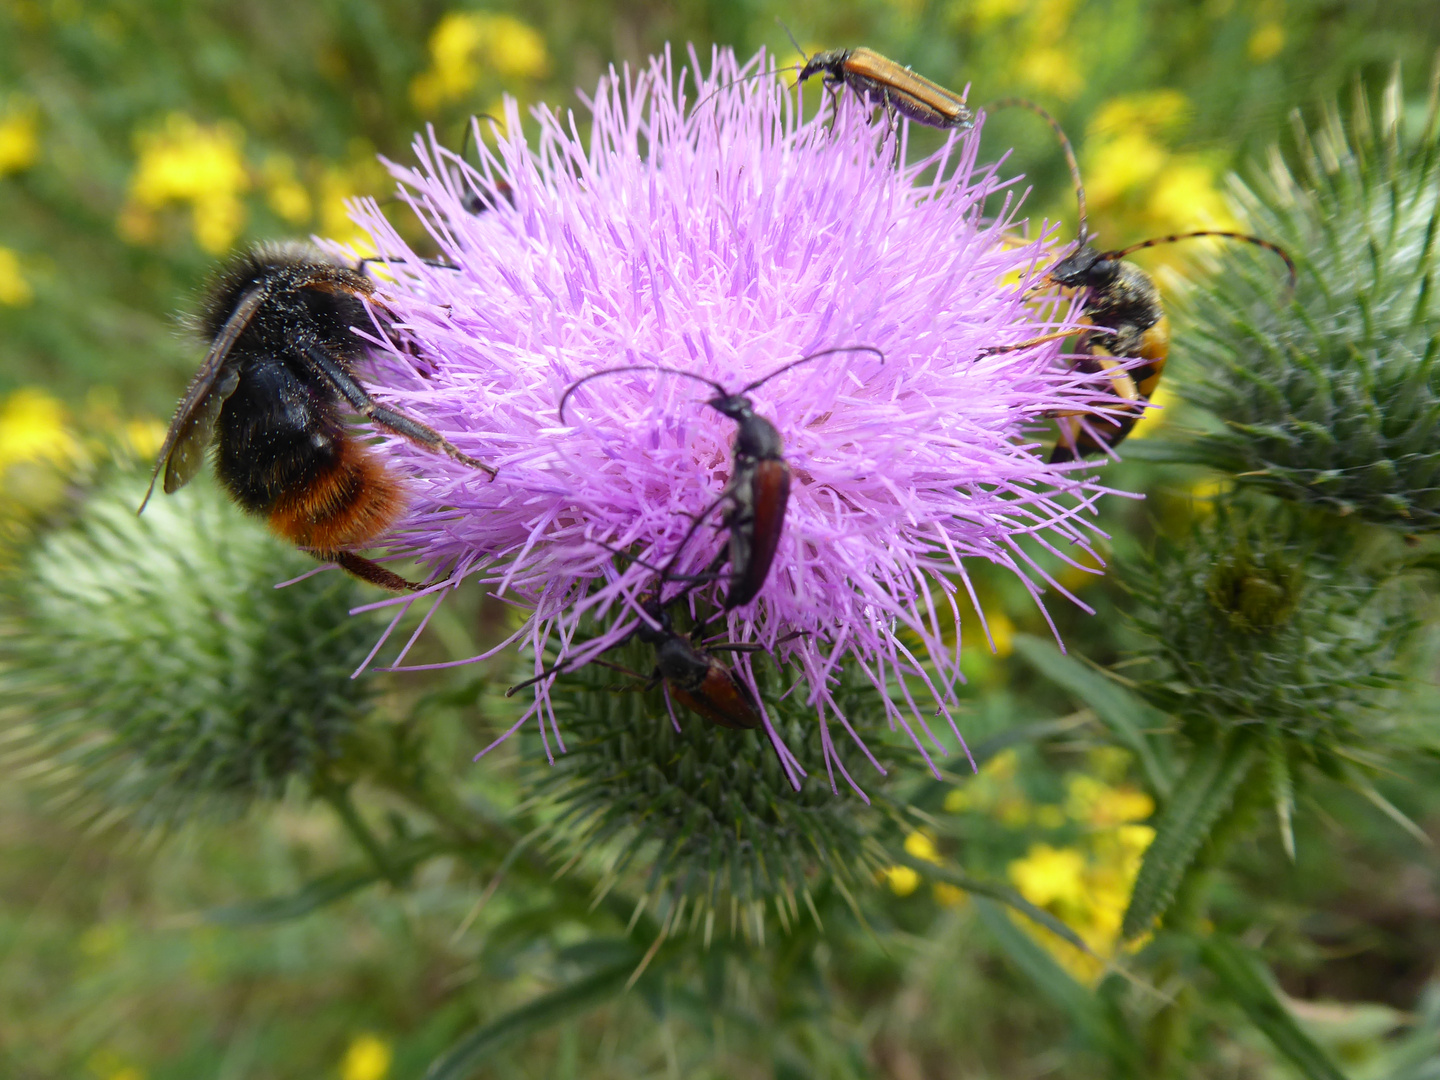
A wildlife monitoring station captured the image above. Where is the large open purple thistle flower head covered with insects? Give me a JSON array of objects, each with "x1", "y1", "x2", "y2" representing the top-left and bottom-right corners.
[{"x1": 342, "y1": 46, "x2": 1103, "y2": 791}]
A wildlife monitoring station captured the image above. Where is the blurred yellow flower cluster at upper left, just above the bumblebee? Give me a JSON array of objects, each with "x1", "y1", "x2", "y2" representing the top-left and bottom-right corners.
[{"x1": 120, "y1": 112, "x2": 251, "y2": 253}]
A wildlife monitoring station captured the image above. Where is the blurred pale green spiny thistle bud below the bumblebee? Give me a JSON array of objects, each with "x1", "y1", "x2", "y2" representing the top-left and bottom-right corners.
[{"x1": 0, "y1": 481, "x2": 376, "y2": 824}]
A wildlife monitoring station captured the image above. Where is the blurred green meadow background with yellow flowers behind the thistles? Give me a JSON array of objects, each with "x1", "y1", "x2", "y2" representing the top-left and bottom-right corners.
[{"x1": 8, "y1": 0, "x2": 1440, "y2": 1080}]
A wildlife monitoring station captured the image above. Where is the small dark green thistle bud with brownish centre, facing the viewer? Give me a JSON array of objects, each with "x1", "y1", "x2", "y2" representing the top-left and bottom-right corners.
[{"x1": 1130, "y1": 501, "x2": 1414, "y2": 760}]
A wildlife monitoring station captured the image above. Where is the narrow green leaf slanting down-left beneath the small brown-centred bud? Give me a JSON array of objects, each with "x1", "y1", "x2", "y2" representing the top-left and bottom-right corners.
[{"x1": 1120, "y1": 733, "x2": 1254, "y2": 940}]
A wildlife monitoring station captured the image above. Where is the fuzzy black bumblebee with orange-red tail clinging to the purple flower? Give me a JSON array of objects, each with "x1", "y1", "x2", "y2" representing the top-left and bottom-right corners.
[{"x1": 137, "y1": 243, "x2": 495, "y2": 590}]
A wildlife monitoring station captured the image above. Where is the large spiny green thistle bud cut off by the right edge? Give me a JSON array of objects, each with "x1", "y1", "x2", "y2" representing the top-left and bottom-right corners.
[{"x1": 1176, "y1": 65, "x2": 1440, "y2": 533}]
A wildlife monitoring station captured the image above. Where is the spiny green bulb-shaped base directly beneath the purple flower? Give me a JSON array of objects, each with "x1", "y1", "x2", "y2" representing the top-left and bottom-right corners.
[{"x1": 527, "y1": 633, "x2": 887, "y2": 939}]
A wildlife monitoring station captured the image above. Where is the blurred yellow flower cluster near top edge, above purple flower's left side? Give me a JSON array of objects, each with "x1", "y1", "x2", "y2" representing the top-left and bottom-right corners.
[{"x1": 410, "y1": 12, "x2": 550, "y2": 112}]
